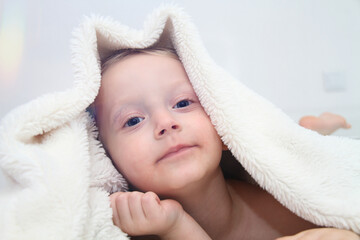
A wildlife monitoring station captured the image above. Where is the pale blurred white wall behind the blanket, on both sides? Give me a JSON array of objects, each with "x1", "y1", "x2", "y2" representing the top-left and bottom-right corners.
[{"x1": 0, "y1": 0, "x2": 360, "y2": 137}]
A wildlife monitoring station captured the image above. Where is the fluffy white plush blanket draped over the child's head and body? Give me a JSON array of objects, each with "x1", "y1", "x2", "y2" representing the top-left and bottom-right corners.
[{"x1": 0, "y1": 4, "x2": 360, "y2": 239}]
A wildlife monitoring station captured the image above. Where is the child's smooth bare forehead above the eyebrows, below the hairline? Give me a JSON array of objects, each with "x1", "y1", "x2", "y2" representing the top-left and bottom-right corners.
[{"x1": 98, "y1": 54, "x2": 194, "y2": 104}]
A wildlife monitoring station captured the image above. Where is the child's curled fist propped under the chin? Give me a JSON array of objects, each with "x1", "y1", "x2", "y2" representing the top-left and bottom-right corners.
[{"x1": 110, "y1": 192, "x2": 185, "y2": 236}]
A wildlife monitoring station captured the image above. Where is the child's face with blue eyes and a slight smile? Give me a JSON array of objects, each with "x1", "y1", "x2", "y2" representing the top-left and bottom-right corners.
[{"x1": 95, "y1": 54, "x2": 222, "y2": 195}]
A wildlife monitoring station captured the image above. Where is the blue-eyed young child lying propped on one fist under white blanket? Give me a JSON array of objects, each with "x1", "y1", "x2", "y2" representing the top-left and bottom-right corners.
[{"x1": 94, "y1": 49, "x2": 359, "y2": 240}]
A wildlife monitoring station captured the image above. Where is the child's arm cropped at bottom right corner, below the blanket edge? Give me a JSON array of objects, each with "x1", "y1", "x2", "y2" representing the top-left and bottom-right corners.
[{"x1": 277, "y1": 228, "x2": 360, "y2": 240}]
